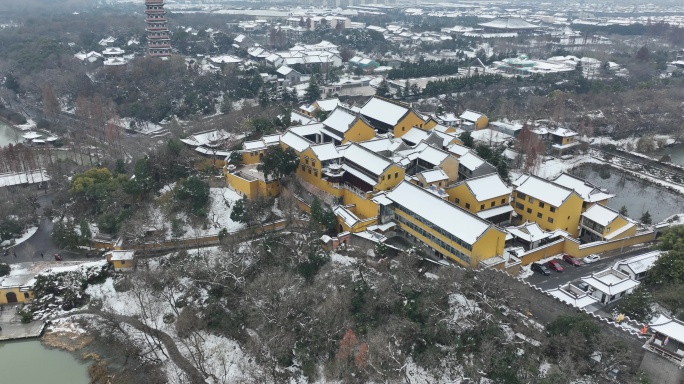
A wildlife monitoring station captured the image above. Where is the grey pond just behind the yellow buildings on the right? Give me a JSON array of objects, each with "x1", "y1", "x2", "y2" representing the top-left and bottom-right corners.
[{"x1": 572, "y1": 164, "x2": 684, "y2": 223}]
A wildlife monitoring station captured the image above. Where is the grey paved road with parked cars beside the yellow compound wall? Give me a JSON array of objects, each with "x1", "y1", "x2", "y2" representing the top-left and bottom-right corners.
[{"x1": 525, "y1": 248, "x2": 654, "y2": 291}]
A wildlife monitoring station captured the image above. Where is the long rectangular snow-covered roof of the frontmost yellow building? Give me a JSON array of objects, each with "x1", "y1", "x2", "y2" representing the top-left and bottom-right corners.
[{"x1": 386, "y1": 181, "x2": 491, "y2": 245}]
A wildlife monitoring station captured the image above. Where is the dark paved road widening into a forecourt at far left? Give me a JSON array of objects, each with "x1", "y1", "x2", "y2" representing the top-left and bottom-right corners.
[{"x1": 0, "y1": 194, "x2": 95, "y2": 264}]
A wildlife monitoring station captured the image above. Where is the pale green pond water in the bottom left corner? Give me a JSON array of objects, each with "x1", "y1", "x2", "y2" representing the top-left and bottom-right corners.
[{"x1": 0, "y1": 339, "x2": 90, "y2": 384}]
